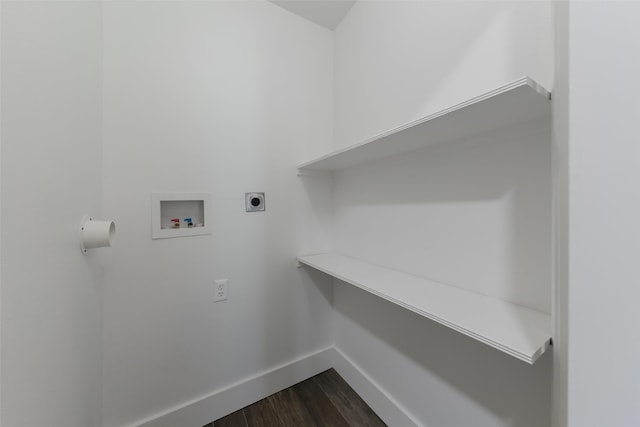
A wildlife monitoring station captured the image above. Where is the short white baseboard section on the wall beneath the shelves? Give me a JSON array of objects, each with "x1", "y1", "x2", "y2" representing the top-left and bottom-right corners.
[{"x1": 331, "y1": 347, "x2": 422, "y2": 427}]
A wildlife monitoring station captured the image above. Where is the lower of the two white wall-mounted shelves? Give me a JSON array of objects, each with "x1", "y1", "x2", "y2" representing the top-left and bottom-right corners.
[{"x1": 298, "y1": 254, "x2": 552, "y2": 364}]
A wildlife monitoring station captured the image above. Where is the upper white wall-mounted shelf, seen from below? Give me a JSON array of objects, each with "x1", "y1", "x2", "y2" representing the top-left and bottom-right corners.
[{"x1": 298, "y1": 77, "x2": 551, "y2": 171}]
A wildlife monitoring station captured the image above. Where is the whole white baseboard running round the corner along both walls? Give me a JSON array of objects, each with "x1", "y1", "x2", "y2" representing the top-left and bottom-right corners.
[{"x1": 130, "y1": 347, "x2": 420, "y2": 427}]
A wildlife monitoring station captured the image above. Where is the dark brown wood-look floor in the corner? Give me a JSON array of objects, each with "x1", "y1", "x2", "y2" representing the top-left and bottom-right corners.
[{"x1": 204, "y1": 369, "x2": 386, "y2": 427}]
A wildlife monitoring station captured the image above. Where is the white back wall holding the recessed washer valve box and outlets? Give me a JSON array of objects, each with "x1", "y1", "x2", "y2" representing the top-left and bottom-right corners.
[{"x1": 103, "y1": 2, "x2": 333, "y2": 427}]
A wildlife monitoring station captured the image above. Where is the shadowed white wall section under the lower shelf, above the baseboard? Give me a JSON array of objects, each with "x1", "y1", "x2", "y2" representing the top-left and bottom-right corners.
[{"x1": 334, "y1": 280, "x2": 552, "y2": 427}]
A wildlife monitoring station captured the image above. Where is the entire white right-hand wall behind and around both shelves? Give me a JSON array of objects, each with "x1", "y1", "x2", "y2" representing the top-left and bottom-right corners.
[{"x1": 331, "y1": 2, "x2": 553, "y2": 427}]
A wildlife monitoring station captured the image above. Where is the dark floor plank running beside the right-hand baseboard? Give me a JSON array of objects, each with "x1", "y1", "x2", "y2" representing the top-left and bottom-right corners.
[{"x1": 313, "y1": 369, "x2": 386, "y2": 427}]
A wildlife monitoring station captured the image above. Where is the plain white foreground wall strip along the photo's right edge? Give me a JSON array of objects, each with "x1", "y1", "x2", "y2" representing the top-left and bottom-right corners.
[{"x1": 565, "y1": 2, "x2": 640, "y2": 427}]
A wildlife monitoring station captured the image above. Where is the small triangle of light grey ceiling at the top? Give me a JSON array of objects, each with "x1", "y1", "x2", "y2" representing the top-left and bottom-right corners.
[{"x1": 269, "y1": 0, "x2": 356, "y2": 30}]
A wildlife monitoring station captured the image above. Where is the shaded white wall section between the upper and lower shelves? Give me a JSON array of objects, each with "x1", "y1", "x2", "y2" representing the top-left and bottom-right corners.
[{"x1": 333, "y1": 118, "x2": 551, "y2": 312}]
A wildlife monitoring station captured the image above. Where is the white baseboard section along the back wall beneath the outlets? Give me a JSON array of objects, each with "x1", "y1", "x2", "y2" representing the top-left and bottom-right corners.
[{"x1": 132, "y1": 347, "x2": 335, "y2": 427}]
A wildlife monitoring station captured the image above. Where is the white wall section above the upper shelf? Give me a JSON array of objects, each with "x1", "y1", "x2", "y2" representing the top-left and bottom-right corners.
[{"x1": 334, "y1": 0, "x2": 553, "y2": 148}]
